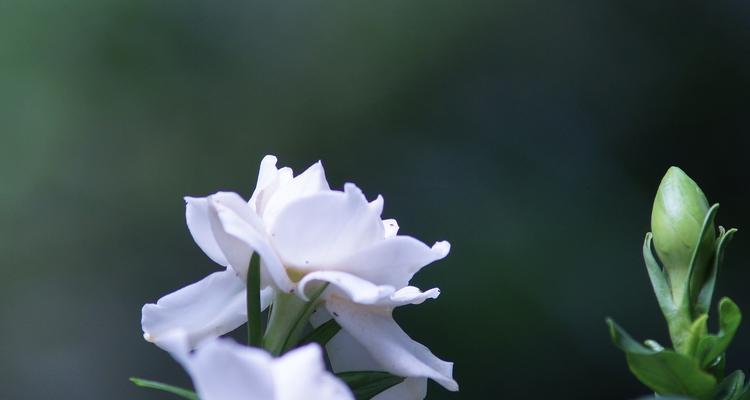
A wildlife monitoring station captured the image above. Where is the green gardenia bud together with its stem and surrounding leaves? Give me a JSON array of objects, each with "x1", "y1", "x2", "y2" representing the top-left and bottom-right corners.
[{"x1": 607, "y1": 167, "x2": 750, "y2": 400}]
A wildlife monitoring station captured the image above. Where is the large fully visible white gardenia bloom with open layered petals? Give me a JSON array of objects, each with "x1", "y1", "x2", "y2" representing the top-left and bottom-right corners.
[{"x1": 142, "y1": 156, "x2": 458, "y2": 390}]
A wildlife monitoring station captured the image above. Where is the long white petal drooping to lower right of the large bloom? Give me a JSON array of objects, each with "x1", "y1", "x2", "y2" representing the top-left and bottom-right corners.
[{"x1": 326, "y1": 296, "x2": 458, "y2": 391}]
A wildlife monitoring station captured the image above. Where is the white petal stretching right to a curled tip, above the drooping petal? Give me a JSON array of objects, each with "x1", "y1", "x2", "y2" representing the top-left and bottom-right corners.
[{"x1": 328, "y1": 236, "x2": 450, "y2": 288}]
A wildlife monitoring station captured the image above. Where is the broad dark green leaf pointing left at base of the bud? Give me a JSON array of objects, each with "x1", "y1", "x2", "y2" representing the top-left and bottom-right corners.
[{"x1": 607, "y1": 319, "x2": 716, "y2": 400}]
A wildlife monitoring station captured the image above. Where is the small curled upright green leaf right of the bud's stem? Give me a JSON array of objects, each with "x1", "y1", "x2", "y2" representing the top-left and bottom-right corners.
[{"x1": 696, "y1": 297, "x2": 742, "y2": 368}]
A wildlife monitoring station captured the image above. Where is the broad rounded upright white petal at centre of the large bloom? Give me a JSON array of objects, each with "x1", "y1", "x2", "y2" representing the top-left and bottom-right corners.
[{"x1": 269, "y1": 184, "x2": 385, "y2": 271}]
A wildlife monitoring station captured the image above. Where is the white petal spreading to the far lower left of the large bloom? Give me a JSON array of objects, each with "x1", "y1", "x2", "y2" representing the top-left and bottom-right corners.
[{"x1": 141, "y1": 269, "x2": 273, "y2": 351}]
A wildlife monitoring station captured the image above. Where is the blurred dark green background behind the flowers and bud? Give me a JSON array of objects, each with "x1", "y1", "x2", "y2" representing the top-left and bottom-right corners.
[{"x1": 0, "y1": 0, "x2": 750, "y2": 400}]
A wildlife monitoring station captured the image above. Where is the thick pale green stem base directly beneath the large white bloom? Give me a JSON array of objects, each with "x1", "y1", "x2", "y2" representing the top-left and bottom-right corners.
[{"x1": 263, "y1": 284, "x2": 328, "y2": 356}]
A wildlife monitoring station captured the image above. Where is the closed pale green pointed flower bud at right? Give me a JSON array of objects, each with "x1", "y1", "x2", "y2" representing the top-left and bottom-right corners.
[{"x1": 651, "y1": 167, "x2": 716, "y2": 302}]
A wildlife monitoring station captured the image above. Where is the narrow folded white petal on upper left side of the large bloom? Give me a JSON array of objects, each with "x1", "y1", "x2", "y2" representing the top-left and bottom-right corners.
[{"x1": 209, "y1": 192, "x2": 294, "y2": 292}]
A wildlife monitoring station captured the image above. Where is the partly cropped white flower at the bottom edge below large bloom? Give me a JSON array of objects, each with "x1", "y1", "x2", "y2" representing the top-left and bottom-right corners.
[{"x1": 167, "y1": 338, "x2": 354, "y2": 400}]
